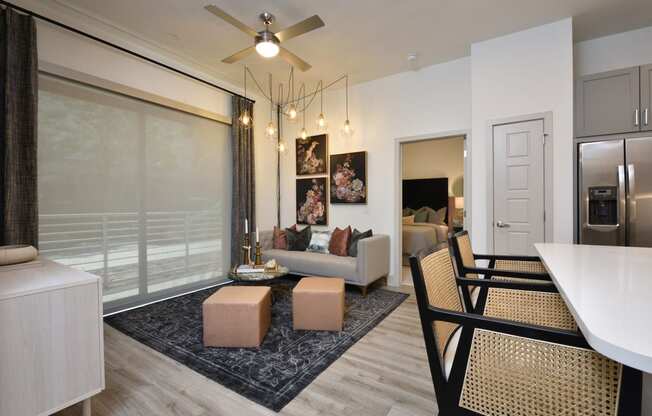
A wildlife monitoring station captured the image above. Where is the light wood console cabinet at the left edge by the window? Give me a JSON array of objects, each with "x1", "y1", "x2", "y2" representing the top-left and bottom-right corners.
[{"x1": 0, "y1": 259, "x2": 104, "y2": 416}]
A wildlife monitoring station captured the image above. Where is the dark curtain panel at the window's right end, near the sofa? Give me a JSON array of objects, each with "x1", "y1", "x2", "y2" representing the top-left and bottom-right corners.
[{"x1": 231, "y1": 96, "x2": 256, "y2": 265}]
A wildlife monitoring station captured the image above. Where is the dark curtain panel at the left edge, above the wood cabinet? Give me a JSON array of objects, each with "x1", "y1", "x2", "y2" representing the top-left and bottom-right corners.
[{"x1": 0, "y1": 8, "x2": 38, "y2": 247}]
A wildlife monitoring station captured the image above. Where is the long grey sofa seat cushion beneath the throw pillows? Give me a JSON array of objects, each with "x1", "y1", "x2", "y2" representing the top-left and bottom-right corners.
[{"x1": 263, "y1": 250, "x2": 358, "y2": 282}]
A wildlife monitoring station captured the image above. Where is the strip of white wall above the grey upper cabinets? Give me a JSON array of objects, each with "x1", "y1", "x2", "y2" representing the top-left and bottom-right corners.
[{"x1": 575, "y1": 26, "x2": 652, "y2": 76}]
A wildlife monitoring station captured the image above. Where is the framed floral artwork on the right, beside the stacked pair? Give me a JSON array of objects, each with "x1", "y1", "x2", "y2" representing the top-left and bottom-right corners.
[{"x1": 330, "y1": 152, "x2": 368, "y2": 204}]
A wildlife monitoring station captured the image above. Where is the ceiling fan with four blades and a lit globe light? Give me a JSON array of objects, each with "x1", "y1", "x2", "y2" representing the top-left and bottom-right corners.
[{"x1": 204, "y1": 5, "x2": 324, "y2": 71}]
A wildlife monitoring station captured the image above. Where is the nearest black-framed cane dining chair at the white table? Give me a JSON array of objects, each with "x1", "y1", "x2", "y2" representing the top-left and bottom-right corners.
[{"x1": 410, "y1": 249, "x2": 641, "y2": 416}]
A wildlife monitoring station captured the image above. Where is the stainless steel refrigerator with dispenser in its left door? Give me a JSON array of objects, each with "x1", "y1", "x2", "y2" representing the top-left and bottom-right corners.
[{"x1": 578, "y1": 137, "x2": 652, "y2": 247}]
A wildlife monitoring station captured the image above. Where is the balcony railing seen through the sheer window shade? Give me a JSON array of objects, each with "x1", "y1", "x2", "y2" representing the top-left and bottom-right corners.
[{"x1": 39, "y1": 209, "x2": 228, "y2": 301}]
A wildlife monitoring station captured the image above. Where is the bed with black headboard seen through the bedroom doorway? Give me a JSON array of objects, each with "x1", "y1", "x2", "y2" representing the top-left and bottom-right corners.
[{"x1": 402, "y1": 178, "x2": 454, "y2": 265}]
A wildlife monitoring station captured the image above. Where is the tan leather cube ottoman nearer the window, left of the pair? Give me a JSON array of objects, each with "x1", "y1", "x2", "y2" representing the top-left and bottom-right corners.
[{"x1": 202, "y1": 286, "x2": 272, "y2": 348}]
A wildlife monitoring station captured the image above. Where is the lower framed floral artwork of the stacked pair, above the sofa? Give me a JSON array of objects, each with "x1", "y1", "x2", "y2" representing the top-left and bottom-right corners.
[{"x1": 297, "y1": 178, "x2": 328, "y2": 225}]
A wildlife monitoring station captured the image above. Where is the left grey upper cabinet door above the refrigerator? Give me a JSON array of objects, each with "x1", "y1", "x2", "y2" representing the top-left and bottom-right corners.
[{"x1": 575, "y1": 67, "x2": 641, "y2": 137}]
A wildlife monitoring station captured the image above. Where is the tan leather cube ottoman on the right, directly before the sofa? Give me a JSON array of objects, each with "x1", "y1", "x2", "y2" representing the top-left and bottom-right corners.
[{"x1": 292, "y1": 277, "x2": 344, "y2": 331}]
